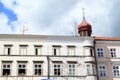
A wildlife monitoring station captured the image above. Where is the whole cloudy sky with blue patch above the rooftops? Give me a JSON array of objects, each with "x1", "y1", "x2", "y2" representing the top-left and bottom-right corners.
[{"x1": 0, "y1": 0, "x2": 120, "y2": 37}]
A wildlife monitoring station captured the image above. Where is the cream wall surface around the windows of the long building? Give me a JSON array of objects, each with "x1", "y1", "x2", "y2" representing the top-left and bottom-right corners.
[{"x1": 0, "y1": 37, "x2": 96, "y2": 80}]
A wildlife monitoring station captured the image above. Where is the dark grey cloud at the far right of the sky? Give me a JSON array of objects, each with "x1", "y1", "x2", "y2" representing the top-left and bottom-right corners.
[{"x1": 109, "y1": 0, "x2": 120, "y2": 37}]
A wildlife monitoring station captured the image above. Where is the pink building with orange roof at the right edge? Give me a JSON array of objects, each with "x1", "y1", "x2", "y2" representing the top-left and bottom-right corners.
[{"x1": 95, "y1": 37, "x2": 120, "y2": 80}]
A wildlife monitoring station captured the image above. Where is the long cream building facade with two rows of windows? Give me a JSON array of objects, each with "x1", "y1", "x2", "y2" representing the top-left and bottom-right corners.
[{"x1": 0, "y1": 34, "x2": 97, "y2": 80}]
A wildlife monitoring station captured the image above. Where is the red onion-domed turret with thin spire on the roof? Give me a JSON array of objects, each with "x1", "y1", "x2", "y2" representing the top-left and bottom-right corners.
[{"x1": 78, "y1": 8, "x2": 92, "y2": 37}]
